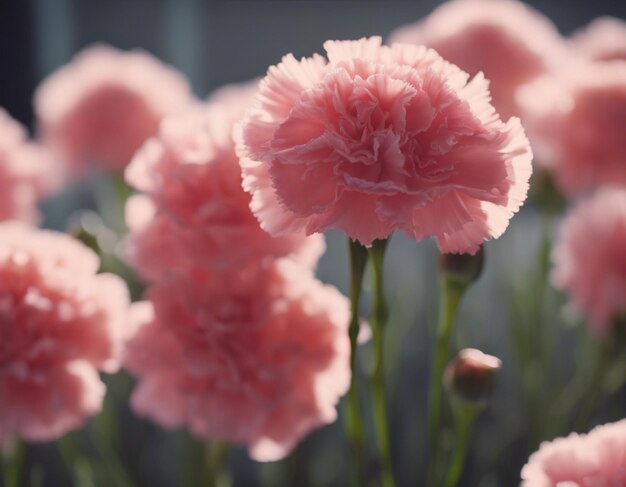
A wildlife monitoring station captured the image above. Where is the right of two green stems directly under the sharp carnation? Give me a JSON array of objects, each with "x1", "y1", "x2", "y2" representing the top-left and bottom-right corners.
[{"x1": 369, "y1": 240, "x2": 396, "y2": 487}]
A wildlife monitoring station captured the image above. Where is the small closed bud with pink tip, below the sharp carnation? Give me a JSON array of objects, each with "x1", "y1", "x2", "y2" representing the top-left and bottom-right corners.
[{"x1": 446, "y1": 348, "x2": 502, "y2": 402}]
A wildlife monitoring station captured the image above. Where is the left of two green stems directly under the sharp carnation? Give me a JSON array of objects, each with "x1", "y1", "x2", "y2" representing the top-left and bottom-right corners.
[{"x1": 347, "y1": 239, "x2": 367, "y2": 487}]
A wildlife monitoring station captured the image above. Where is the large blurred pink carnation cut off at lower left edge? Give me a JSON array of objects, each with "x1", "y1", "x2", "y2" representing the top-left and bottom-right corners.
[{"x1": 0, "y1": 222, "x2": 129, "y2": 443}]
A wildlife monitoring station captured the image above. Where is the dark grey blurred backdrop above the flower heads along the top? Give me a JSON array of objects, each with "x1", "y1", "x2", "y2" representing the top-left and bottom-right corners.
[{"x1": 0, "y1": 0, "x2": 626, "y2": 130}]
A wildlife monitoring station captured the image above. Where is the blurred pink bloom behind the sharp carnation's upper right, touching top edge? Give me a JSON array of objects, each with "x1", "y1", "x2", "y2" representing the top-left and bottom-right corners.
[{"x1": 390, "y1": 0, "x2": 566, "y2": 118}]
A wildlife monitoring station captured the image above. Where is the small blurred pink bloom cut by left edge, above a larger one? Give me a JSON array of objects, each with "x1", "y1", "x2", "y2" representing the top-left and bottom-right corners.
[{"x1": 0, "y1": 108, "x2": 61, "y2": 223}]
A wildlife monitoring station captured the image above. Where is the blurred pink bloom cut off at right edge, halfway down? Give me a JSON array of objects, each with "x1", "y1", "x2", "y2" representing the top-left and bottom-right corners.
[{"x1": 552, "y1": 188, "x2": 626, "y2": 334}]
